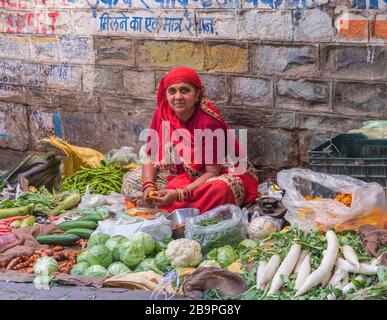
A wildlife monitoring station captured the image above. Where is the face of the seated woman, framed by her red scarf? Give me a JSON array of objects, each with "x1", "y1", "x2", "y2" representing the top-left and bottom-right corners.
[{"x1": 167, "y1": 82, "x2": 199, "y2": 121}]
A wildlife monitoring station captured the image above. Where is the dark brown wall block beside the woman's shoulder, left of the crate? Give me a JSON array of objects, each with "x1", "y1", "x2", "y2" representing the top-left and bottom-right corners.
[{"x1": 247, "y1": 128, "x2": 299, "y2": 169}]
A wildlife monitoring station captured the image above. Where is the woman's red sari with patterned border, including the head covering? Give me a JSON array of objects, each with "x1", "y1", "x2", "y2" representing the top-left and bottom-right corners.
[{"x1": 147, "y1": 68, "x2": 258, "y2": 213}]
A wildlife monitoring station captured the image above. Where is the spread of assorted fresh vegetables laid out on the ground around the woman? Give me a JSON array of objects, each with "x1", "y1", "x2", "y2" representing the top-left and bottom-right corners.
[{"x1": 0, "y1": 150, "x2": 387, "y2": 300}]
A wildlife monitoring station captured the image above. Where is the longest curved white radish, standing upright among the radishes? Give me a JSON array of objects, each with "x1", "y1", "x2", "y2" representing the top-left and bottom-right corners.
[{"x1": 295, "y1": 230, "x2": 339, "y2": 297}]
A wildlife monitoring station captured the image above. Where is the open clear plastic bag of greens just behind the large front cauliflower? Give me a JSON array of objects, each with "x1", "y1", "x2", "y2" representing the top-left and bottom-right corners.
[{"x1": 184, "y1": 204, "x2": 247, "y2": 254}]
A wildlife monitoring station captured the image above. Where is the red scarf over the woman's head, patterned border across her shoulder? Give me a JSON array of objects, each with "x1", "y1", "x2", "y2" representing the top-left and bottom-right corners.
[{"x1": 151, "y1": 68, "x2": 246, "y2": 172}]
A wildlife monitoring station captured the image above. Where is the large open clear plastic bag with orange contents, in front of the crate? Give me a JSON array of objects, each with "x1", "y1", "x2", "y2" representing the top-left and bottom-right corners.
[{"x1": 277, "y1": 168, "x2": 387, "y2": 231}]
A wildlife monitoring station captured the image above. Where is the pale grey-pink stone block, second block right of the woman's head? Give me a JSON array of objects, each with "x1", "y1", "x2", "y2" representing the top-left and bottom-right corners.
[{"x1": 231, "y1": 77, "x2": 273, "y2": 107}]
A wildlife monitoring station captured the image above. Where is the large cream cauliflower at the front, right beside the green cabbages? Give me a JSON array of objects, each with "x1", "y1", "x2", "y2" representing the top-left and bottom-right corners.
[{"x1": 165, "y1": 238, "x2": 202, "y2": 267}]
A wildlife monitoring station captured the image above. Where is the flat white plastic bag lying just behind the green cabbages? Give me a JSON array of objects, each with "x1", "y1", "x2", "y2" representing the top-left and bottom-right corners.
[{"x1": 93, "y1": 216, "x2": 172, "y2": 241}]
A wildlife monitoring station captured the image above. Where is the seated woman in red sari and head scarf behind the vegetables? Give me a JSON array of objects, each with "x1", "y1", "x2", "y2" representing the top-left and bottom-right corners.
[{"x1": 142, "y1": 68, "x2": 258, "y2": 213}]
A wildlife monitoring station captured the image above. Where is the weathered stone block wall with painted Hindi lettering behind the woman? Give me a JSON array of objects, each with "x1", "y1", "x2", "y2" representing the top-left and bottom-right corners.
[{"x1": 0, "y1": 0, "x2": 387, "y2": 179}]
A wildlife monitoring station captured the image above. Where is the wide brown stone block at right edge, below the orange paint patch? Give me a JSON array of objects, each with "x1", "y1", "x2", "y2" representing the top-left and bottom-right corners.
[{"x1": 321, "y1": 45, "x2": 387, "y2": 80}]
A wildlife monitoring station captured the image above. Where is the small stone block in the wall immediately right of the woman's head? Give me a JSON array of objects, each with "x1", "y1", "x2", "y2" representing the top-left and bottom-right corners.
[{"x1": 200, "y1": 74, "x2": 230, "y2": 105}]
